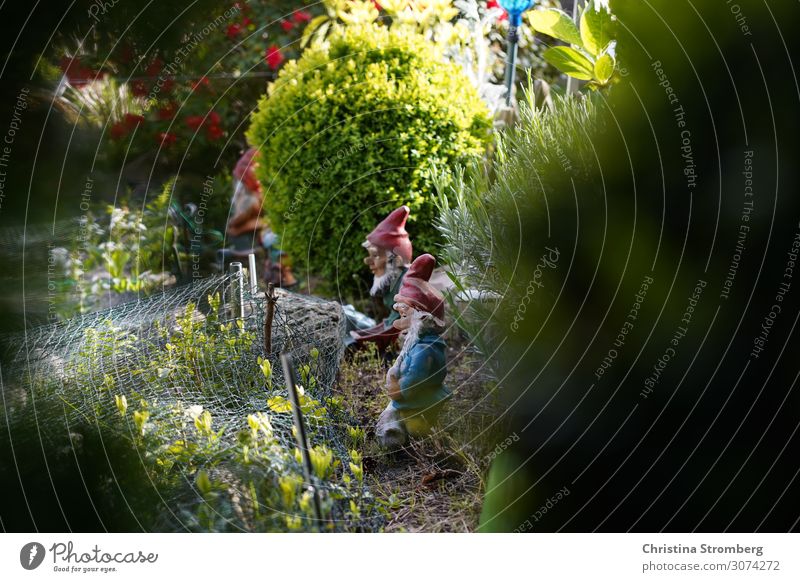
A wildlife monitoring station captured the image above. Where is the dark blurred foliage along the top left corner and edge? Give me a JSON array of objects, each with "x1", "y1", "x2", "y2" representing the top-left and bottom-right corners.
[{"x1": 0, "y1": 0, "x2": 225, "y2": 335}]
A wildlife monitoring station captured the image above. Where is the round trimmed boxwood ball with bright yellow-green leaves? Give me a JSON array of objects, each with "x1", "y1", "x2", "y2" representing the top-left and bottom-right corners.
[{"x1": 247, "y1": 25, "x2": 491, "y2": 297}]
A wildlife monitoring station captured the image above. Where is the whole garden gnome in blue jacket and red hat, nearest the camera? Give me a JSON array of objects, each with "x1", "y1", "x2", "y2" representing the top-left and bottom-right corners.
[{"x1": 375, "y1": 254, "x2": 450, "y2": 448}]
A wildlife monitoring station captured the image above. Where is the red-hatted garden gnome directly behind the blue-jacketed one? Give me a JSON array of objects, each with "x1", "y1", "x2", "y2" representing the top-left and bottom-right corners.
[{"x1": 350, "y1": 206, "x2": 412, "y2": 350}]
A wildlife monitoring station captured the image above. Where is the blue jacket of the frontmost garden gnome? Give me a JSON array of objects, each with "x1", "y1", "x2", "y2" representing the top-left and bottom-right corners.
[{"x1": 392, "y1": 333, "x2": 450, "y2": 410}]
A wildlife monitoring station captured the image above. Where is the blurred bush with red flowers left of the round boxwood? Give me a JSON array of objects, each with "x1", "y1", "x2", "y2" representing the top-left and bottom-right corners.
[{"x1": 54, "y1": 0, "x2": 324, "y2": 171}]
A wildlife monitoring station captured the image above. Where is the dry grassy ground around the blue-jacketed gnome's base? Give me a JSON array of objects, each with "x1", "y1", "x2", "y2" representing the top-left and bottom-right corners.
[{"x1": 339, "y1": 340, "x2": 502, "y2": 532}]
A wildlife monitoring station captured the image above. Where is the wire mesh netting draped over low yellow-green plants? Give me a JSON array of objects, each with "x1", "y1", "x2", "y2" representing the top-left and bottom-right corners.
[{"x1": 0, "y1": 275, "x2": 378, "y2": 531}]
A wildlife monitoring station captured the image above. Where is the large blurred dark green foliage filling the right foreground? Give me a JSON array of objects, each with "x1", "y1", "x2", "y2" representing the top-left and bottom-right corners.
[{"x1": 482, "y1": 0, "x2": 800, "y2": 532}]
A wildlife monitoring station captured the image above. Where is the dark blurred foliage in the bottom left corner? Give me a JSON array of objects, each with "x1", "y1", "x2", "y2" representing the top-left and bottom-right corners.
[{"x1": 0, "y1": 402, "x2": 179, "y2": 532}]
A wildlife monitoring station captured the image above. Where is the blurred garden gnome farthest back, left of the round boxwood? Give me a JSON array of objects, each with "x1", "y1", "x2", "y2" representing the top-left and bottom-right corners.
[{"x1": 227, "y1": 148, "x2": 297, "y2": 287}]
